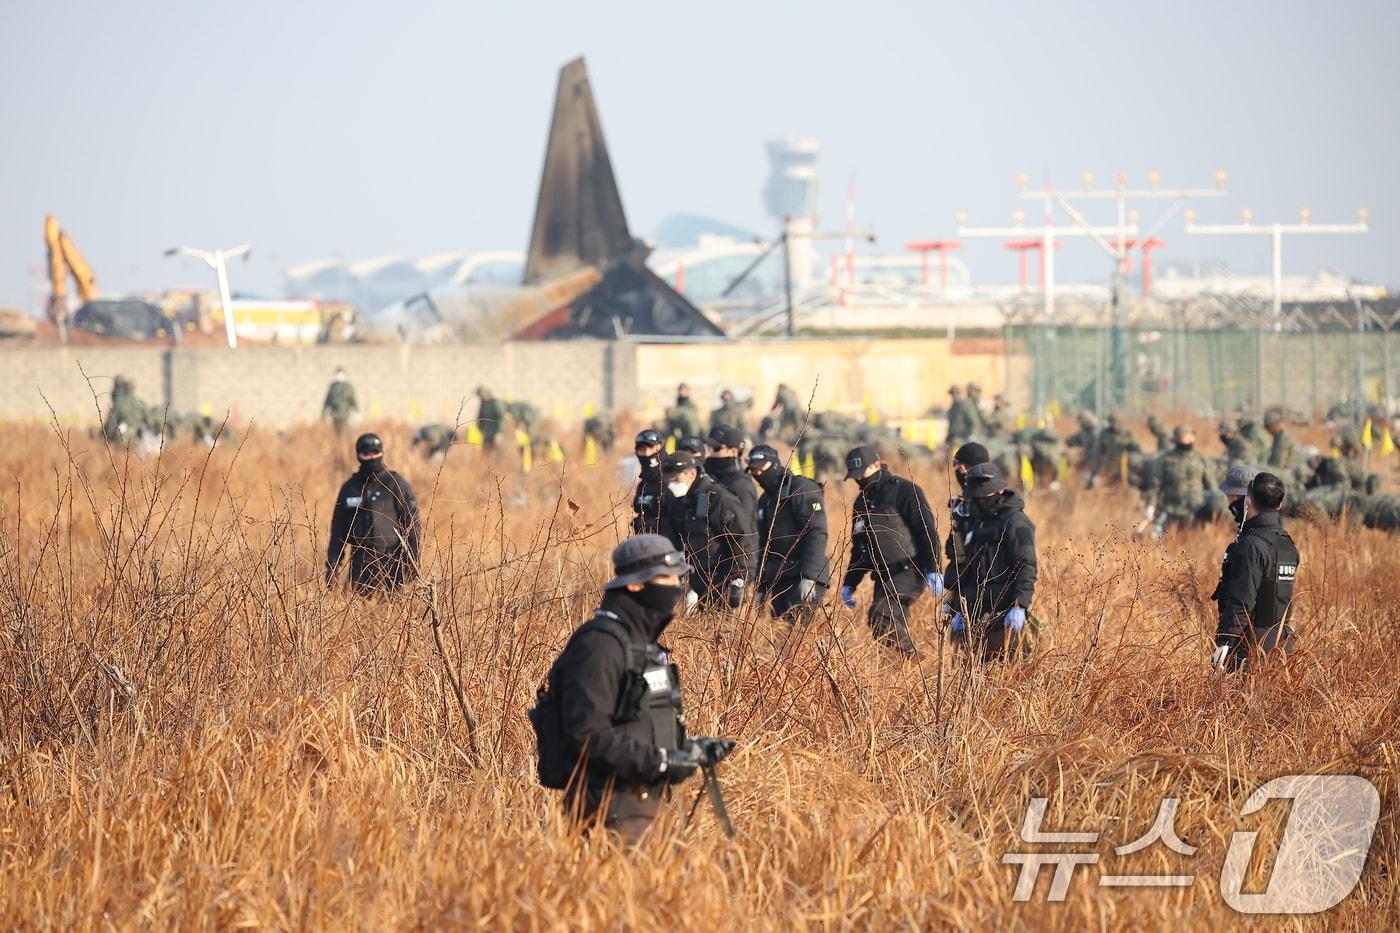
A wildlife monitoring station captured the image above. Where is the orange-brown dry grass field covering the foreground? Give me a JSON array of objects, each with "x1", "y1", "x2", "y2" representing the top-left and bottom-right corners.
[{"x1": 0, "y1": 426, "x2": 1400, "y2": 930}]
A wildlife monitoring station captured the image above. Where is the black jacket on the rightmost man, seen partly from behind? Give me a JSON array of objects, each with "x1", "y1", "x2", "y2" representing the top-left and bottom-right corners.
[{"x1": 1211, "y1": 511, "x2": 1298, "y2": 644}]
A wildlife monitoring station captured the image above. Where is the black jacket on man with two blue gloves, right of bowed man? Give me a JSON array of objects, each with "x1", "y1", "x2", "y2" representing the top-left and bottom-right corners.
[{"x1": 945, "y1": 489, "x2": 1036, "y2": 619}]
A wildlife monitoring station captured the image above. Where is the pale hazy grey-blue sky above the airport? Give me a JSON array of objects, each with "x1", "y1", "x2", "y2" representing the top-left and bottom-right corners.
[{"x1": 0, "y1": 0, "x2": 1400, "y2": 307}]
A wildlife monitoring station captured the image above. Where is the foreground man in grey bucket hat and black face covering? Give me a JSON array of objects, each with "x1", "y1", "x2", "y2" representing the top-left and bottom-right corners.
[{"x1": 529, "y1": 535, "x2": 703, "y2": 843}]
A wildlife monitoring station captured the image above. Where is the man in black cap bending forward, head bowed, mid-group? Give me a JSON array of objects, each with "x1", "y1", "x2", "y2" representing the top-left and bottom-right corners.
[{"x1": 841, "y1": 447, "x2": 944, "y2": 656}]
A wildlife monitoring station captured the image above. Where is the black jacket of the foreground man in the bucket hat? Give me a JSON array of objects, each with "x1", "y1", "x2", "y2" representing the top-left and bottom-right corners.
[{"x1": 550, "y1": 590, "x2": 685, "y2": 786}]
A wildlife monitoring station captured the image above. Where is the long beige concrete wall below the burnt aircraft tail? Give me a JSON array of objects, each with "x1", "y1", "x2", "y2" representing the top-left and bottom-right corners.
[{"x1": 0, "y1": 338, "x2": 1023, "y2": 426}]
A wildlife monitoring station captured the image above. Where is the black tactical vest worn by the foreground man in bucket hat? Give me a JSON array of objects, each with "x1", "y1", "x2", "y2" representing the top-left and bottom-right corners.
[{"x1": 529, "y1": 609, "x2": 686, "y2": 790}]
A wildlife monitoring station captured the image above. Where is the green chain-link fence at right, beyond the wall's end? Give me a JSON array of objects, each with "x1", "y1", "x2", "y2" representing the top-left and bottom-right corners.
[{"x1": 1005, "y1": 298, "x2": 1400, "y2": 417}]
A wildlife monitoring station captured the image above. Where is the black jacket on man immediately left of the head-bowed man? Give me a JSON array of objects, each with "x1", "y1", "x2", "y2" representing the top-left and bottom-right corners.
[{"x1": 757, "y1": 464, "x2": 832, "y2": 590}]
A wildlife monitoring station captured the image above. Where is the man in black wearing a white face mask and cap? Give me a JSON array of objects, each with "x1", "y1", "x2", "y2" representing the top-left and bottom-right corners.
[{"x1": 661, "y1": 452, "x2": 757, "y2": 609}]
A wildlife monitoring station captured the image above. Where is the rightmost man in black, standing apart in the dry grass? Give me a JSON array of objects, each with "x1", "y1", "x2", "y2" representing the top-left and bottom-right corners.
[{"x1": 1211, "y1": 469, "x2": 1298, "y2": 671}]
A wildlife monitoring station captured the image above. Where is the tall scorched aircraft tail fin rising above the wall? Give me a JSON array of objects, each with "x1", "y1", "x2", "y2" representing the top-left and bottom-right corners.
[{"x1": 525, "y1": 59, "x2": 633, "y2": 284}]
